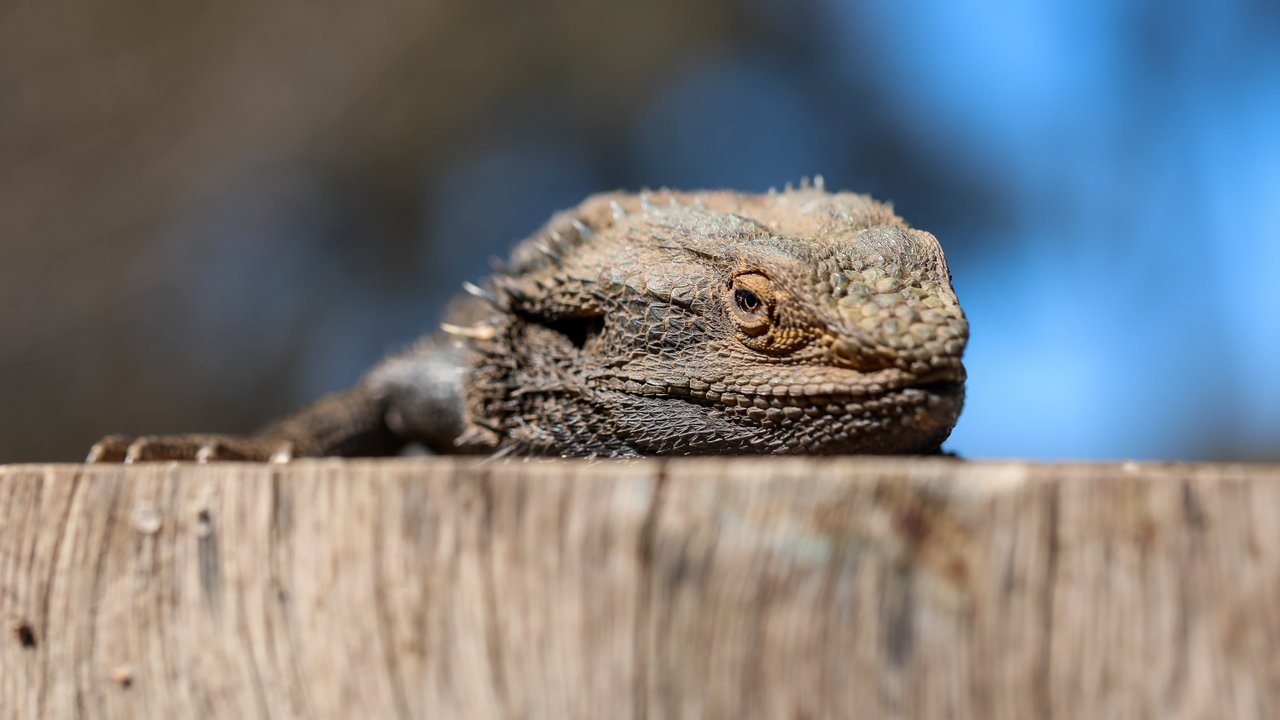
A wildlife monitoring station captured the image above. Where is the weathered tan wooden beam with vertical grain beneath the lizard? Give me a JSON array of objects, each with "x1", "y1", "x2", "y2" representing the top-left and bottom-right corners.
[{"x1": 0, "y1": 459, "x2": 1280, "y2": 719}]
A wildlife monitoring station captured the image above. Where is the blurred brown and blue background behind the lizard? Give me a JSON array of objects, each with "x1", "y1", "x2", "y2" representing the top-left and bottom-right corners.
[{"x1": 0, "y1": 0, "x2": 1280, "y2": 461}]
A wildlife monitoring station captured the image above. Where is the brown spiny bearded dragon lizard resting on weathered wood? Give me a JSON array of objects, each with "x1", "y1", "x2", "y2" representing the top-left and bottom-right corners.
[{"x1": 91, "y1": 187, "x2": 969, "y2": 460}]
